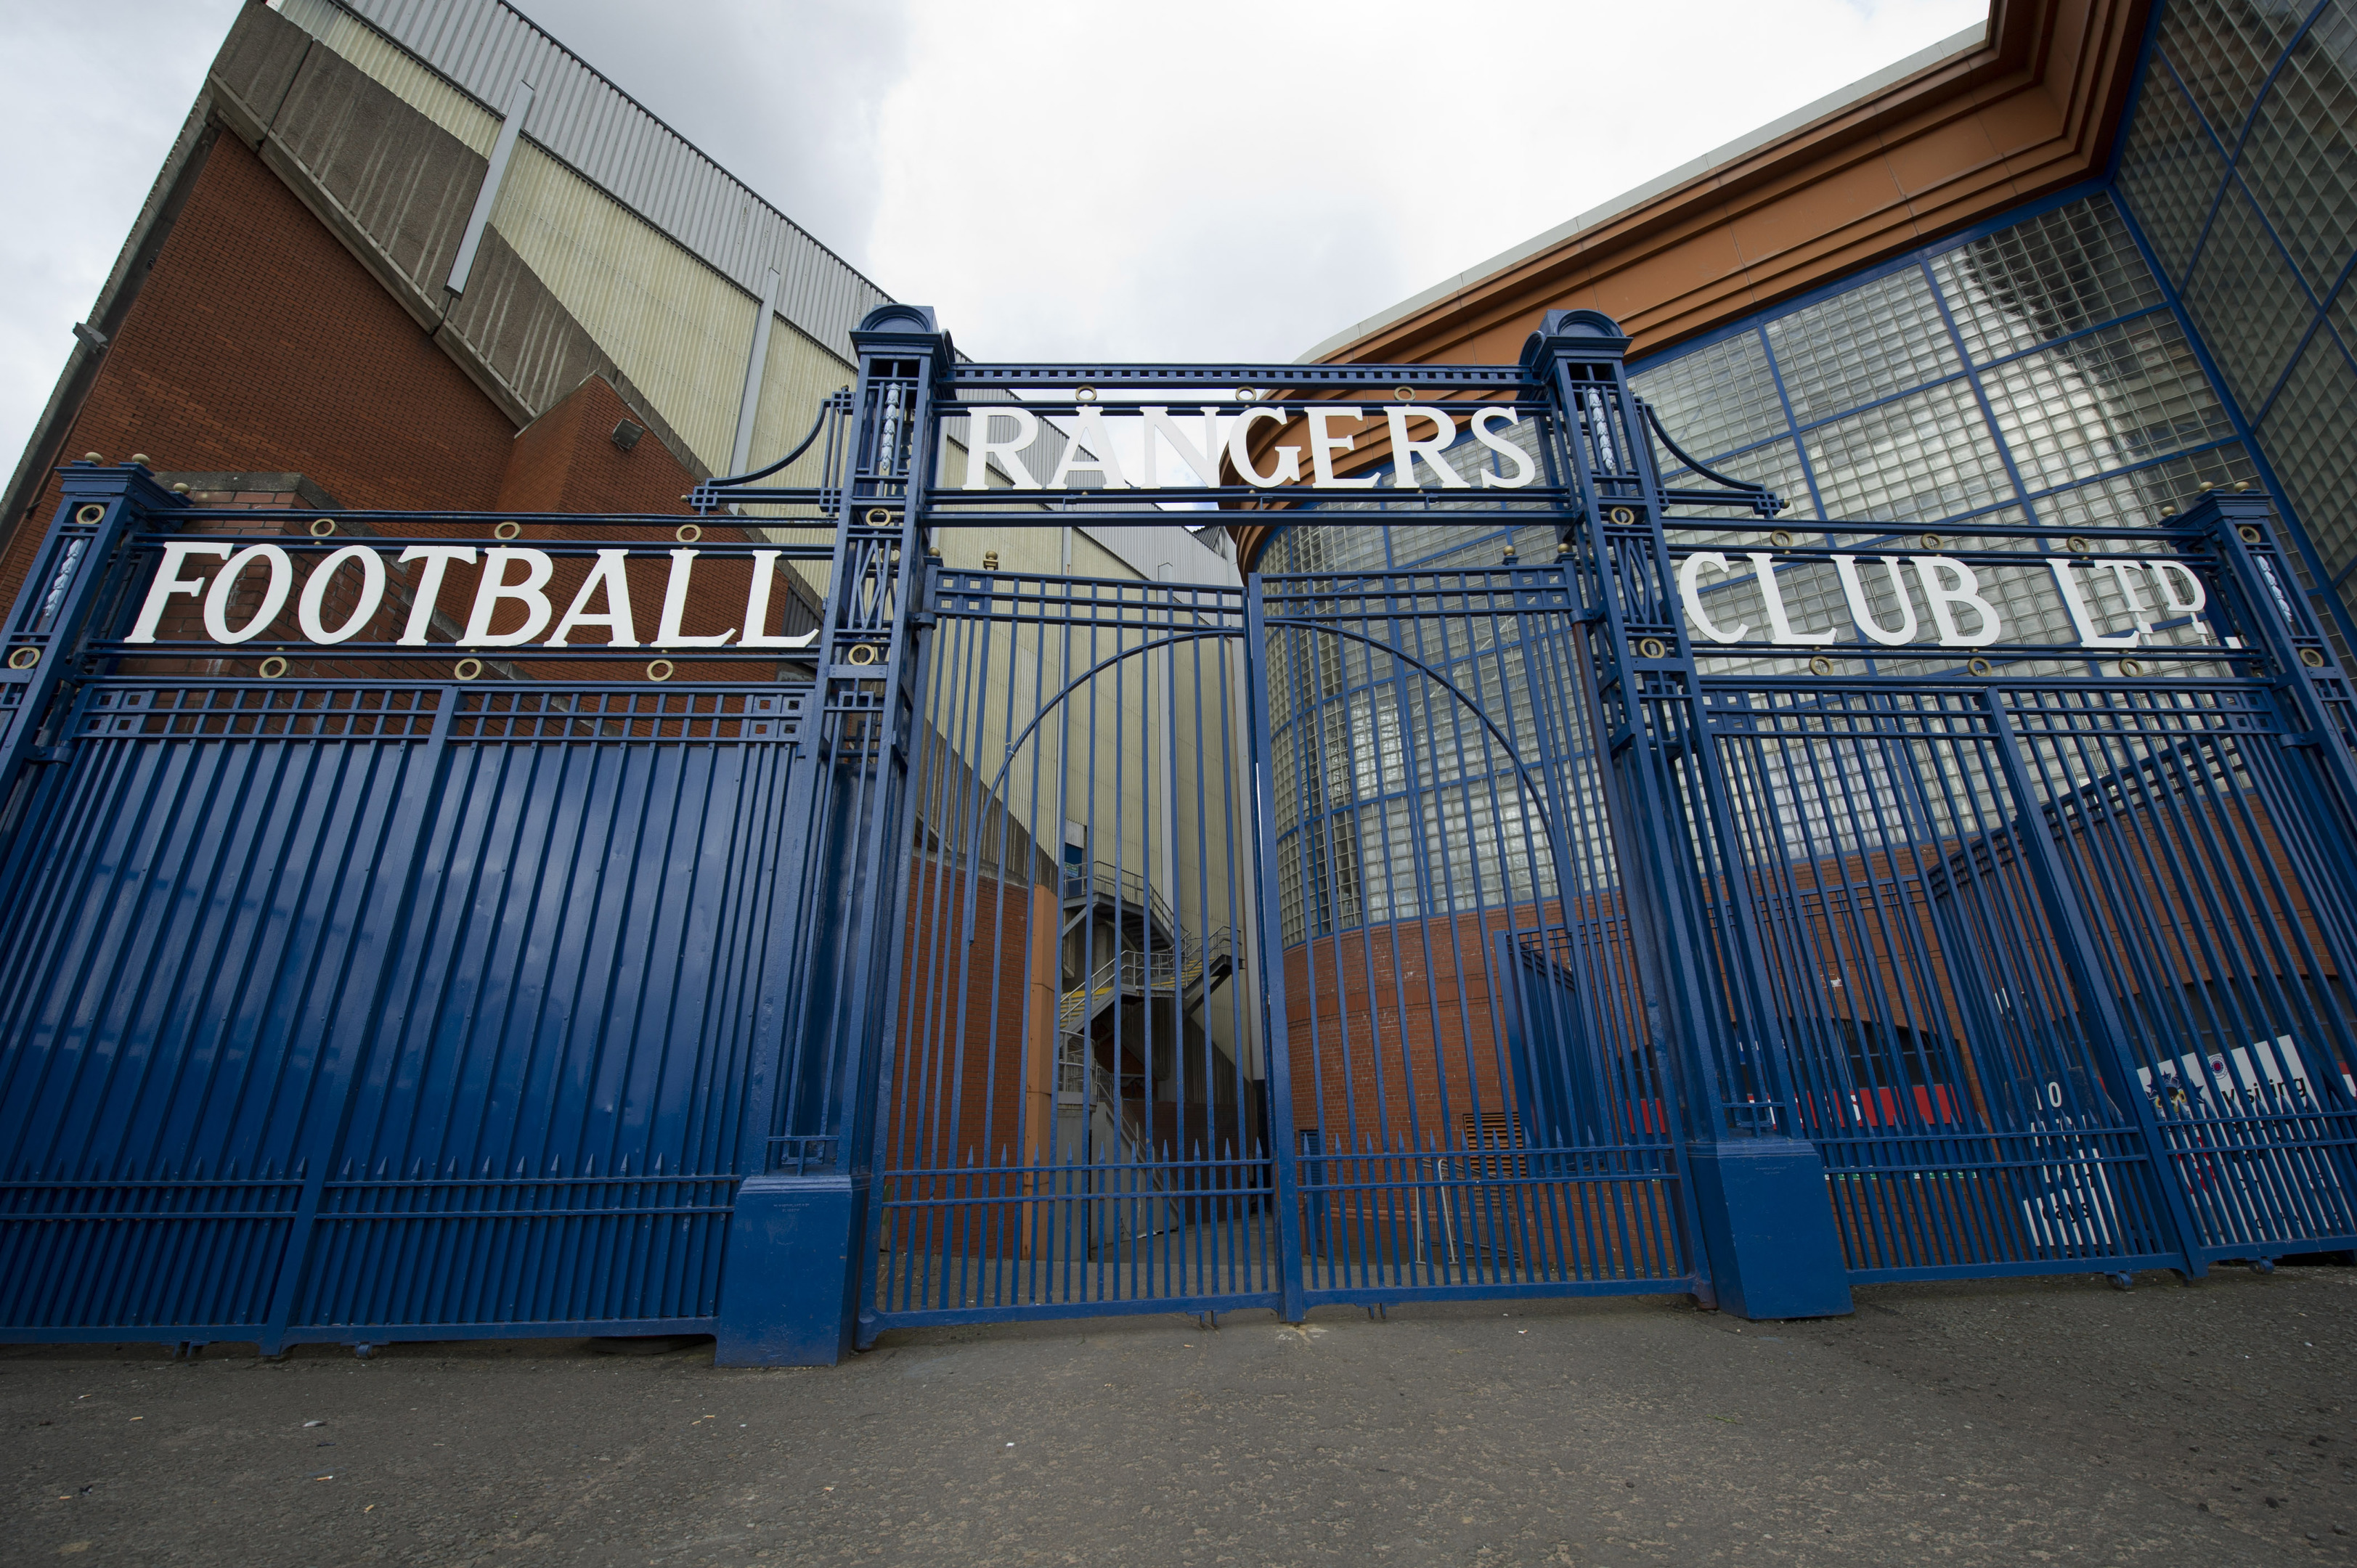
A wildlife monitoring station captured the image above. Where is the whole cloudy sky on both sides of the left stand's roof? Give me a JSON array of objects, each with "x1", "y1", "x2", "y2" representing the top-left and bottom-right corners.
[{"x1": 0, "y1": 0, "x2": 1987, "y2": 455}]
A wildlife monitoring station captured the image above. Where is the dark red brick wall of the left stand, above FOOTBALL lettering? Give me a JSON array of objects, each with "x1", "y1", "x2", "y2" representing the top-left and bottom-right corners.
[{"x1": 0, "y1": 136, "x2": 516, "y2": 601}]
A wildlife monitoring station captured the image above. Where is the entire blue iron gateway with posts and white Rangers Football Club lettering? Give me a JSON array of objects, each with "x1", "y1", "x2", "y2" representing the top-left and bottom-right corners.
[{"x1": 0, "y1": 306, "x2": 2357, "y2": 1360}]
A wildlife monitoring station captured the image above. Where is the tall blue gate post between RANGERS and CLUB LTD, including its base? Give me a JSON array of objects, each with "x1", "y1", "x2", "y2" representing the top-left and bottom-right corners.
[{"x1": 1523, "y1": 311, "x2": 1850, "y2": 1318}]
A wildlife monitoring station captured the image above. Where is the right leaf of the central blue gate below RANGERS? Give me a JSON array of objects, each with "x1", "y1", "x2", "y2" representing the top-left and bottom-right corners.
[{"x1": 1252, "y1": 566, "x2": 1709, "y2": 1306}]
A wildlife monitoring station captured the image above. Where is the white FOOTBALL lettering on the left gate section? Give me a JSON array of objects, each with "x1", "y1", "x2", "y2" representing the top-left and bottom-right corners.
[{"x1": 125, "y1": 540, "x2": 818, "y2": 648}]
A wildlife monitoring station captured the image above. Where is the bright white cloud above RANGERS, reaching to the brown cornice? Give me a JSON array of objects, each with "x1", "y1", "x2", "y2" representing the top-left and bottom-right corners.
[{"x1": 868, "y1": 0, "x2": 1987, "y2": 361}]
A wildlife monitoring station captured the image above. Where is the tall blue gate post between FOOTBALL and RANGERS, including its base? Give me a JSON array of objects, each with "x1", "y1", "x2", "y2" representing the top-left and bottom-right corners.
[{"x1": 715, "y1": 304, "x2": 950, "y2": 1365}]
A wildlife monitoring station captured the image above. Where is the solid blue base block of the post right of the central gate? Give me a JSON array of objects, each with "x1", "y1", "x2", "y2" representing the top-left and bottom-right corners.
[{"x1": 1688, "y1": 1139, "x2": 1852, "y2": 1320}]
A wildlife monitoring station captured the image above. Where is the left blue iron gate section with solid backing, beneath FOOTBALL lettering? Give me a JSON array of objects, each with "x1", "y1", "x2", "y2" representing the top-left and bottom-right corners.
[{"x1": 0, "y1": 469, "x2": 839, "y2": 1351}]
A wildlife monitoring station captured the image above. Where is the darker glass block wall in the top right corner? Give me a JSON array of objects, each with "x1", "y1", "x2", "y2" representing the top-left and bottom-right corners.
[{"x1": 2117, "y1": 0, "x2": 2357, "y2": 622}]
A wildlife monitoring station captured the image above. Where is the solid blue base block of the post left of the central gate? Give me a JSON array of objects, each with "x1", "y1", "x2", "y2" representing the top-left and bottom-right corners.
[{"x1": 712, "y1": 1175, "x2": 863, "y2": 1368}]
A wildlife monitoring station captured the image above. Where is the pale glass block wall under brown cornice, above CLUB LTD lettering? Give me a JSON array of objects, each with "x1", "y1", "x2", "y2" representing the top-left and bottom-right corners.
[{"x1": 1261, "y1": 193, "x2": 2258, "y2": 594}]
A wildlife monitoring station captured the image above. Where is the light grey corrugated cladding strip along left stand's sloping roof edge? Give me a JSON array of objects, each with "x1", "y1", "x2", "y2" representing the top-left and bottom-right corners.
[{"x1": 283, "y1": 0, "x2": 891, "y2": 356}]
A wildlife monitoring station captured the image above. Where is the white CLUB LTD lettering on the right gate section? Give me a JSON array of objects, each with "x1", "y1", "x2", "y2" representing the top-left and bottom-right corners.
[{"x1": 1678, "y1": 550, "x2": 2209, "y2": 648}]
